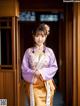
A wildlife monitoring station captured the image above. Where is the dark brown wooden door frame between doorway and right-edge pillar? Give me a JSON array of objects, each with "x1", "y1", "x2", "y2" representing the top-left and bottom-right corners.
[{"x1": 59, "y1": 4, "x2": 74, "y2": 106}]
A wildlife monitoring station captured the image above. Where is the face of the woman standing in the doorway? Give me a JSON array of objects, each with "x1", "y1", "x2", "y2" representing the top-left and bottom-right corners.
[{"x1": 34, "y1": 31, "x2": 46, "y2": 46}]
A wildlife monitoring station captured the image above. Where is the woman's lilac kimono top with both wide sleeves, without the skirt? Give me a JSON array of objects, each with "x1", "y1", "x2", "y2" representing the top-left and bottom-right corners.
[{"x1": 21, "y1": 47, "x2": 58, "y2": 83}]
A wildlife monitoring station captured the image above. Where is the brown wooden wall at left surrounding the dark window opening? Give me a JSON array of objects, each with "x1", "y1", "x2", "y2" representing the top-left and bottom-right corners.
[{"x1": 0, "y1": 0, "x2": 20, "y2": 106}]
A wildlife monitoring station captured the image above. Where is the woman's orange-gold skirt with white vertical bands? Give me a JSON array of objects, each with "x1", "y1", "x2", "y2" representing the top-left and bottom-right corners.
[{"x1": 26, "y1": 80, "x2": 55, "y2": 106}]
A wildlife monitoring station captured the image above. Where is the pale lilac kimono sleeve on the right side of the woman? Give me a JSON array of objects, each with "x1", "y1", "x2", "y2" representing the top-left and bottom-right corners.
[{"x1": 39, "y1": 49, "x2": 58, "y2": 80}]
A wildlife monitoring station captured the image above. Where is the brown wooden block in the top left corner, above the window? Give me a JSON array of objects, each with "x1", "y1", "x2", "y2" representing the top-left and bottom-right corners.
[{"x1": 0, "y1": 0, "x2": 19, "y2": 17}]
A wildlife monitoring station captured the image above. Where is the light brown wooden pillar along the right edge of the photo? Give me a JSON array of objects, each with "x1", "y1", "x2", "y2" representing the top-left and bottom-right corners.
[{"x1": 73, "y1": 3, "x2": 80, "y2": 106}]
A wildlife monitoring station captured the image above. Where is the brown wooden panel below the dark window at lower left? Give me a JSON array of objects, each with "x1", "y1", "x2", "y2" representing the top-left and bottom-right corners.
[{"x1": 0, "y1": 70, "x2": 15, "y2": 106}]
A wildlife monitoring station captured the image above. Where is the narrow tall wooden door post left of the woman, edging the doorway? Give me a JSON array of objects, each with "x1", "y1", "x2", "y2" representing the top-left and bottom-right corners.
[{"x1": 15, "y1": 17, "x2": 21, "y2": 106}]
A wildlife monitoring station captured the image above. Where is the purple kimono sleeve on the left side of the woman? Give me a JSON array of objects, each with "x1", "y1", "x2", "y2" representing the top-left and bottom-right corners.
[{"x1": 21, "y1": 50, "x2": 34, "y2": 83}]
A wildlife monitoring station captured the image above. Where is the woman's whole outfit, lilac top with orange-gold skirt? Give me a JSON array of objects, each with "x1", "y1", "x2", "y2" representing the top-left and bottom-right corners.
[{"x1": 22, "y1": 47, "x2": 58, "y2": 106}]
